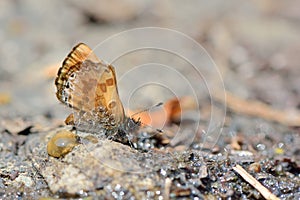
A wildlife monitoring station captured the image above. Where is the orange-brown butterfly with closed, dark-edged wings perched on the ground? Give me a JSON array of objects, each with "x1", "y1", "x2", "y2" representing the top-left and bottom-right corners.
[{"x1": 55, "y1": 43, "x2": 139, "y2": 136}]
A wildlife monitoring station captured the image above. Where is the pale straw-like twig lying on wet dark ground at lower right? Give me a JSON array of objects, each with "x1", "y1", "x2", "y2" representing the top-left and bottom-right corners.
[{"x1": 232, "y1": 165, "x2": 279, "y2": 200}]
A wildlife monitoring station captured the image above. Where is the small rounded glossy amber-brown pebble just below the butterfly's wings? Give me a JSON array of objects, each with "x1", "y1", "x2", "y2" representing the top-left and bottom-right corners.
[{"x1": 47, "y1": 130, "x2": 79, "y2": 158}]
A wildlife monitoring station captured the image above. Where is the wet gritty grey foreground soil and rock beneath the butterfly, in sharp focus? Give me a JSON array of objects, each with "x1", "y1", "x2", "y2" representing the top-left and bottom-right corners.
[{"x1": 0, "y1": 114, "x2": 300, "y2": 199}]
